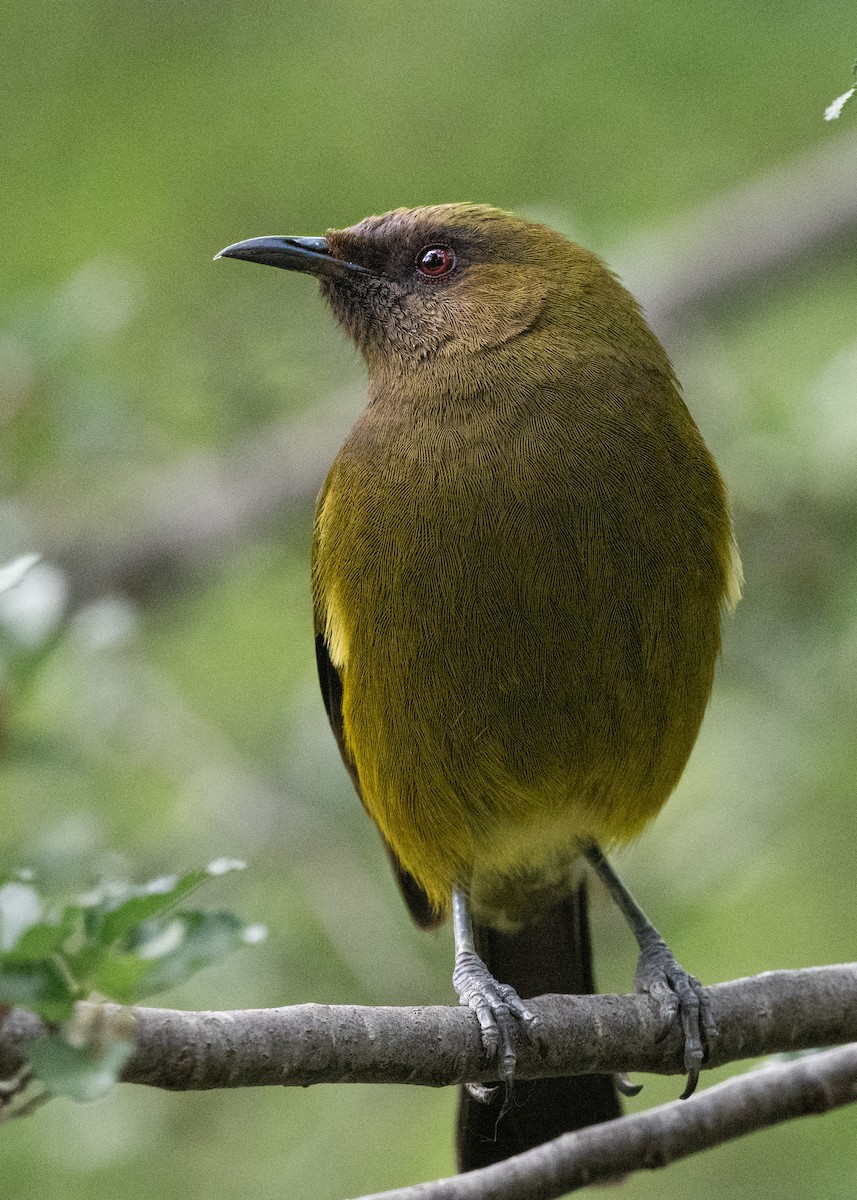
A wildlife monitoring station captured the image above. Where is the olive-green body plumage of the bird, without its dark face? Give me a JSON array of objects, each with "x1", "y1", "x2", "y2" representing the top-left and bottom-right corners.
[{"x1": 313, "y1": 210, "x2": 736, "y2": 928}]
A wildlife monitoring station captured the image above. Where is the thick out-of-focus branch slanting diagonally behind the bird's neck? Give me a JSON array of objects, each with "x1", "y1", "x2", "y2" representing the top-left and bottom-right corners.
[{"x1": 32, "y1": 134, "x2": 857, "y2": 602}]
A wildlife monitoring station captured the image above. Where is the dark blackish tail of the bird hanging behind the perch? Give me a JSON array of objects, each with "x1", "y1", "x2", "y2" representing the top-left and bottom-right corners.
[{"x1": 457, "y1": 883, "x2": 622, "y2": 1171}]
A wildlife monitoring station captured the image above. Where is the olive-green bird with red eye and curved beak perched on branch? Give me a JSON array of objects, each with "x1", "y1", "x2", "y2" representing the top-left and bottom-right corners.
[{"x1": 216, "y1": 203, "x2": 742, "y2": 1171}]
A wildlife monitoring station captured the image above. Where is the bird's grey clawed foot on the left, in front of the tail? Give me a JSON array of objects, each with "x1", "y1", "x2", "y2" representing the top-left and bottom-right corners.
[{"x1": 453, "y1": 949, "x2": 541, "y2": 1093}]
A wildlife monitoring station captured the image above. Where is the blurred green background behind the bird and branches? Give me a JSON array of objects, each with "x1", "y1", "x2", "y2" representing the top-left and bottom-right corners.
[{"x1": 0, "y1": 0, "x2": 857, "y2": 1200}]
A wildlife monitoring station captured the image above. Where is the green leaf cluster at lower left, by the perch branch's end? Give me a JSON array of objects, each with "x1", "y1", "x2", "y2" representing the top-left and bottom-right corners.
[{"x1": 0, "y1": 858, "x2": 260, "y2": 1116}]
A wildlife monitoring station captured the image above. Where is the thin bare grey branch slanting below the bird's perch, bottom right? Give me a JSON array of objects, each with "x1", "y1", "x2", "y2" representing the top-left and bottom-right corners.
[{"x1": 348, "y1": 1045, "x2": 857, "y2": 1200}]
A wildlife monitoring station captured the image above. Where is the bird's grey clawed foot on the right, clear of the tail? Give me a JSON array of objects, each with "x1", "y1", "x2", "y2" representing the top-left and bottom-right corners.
[{"x1": 636, "y1": 929, "x2": 717, "y2": 1100}]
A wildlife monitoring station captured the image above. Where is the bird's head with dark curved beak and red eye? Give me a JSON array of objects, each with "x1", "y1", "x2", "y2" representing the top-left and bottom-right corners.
[{"x1": 217, "y1": 204, "x2": 657, "y2": 386}]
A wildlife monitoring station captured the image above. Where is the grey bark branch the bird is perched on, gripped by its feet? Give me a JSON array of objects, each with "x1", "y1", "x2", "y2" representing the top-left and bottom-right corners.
[{"x1": 0, "y1": 964, "x2": 857, "y2": 1091}]
